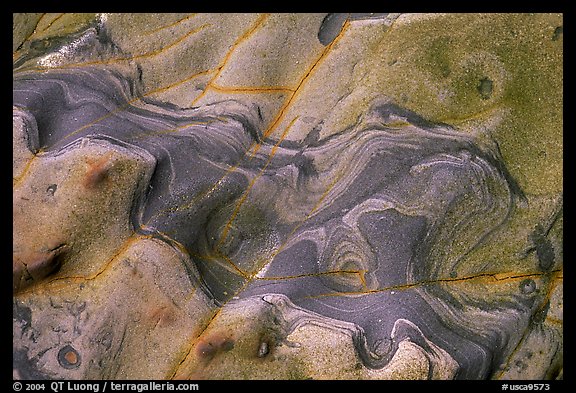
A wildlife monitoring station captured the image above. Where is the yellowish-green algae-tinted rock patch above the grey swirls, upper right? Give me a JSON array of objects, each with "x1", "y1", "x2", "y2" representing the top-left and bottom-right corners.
[{"x1": 356, "y1": 14, "x2": 563, "y2": 194}]
